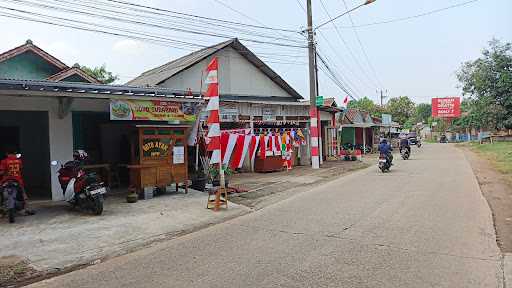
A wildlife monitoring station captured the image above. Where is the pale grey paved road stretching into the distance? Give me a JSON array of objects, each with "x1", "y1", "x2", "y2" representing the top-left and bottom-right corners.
[{"x1": 32, "y1": 144, "x2": 503, "y2": 288}]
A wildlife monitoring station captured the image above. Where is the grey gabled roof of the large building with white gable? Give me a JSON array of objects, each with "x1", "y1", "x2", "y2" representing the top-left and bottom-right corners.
[{"x1": 127, "y1": 38, "x2": 303, "y2": 99}]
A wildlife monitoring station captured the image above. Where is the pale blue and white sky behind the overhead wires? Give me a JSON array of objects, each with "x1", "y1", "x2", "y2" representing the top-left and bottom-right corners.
[{"x1": 0, "y1": 0, "x2": 512, "y2": 103}]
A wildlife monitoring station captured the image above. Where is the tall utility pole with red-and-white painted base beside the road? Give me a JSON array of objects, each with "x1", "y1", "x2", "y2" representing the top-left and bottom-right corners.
[{"x1": 307, "y1": 0, "x2": 320, "y2": 169}]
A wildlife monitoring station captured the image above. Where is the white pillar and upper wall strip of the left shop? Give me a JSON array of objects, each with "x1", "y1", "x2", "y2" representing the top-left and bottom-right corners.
[{"x1": 0, "y1": 96, "x2": 109, "y2": 200}]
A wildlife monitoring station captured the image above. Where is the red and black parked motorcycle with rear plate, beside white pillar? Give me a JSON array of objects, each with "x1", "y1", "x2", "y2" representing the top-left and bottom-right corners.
[{"x1": 51, "y1": 150, "x2": 107, "y2": 215}]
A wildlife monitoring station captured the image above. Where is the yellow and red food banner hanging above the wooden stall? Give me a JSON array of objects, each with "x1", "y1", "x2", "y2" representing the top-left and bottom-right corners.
[{"x1": 110, "y1": 100, "x2": 197, "y2": 122}]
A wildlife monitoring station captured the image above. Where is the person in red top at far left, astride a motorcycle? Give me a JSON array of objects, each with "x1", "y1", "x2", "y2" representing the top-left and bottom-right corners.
[{"x1": 0, "y1": 153, "x2": 35, "y2": 215}]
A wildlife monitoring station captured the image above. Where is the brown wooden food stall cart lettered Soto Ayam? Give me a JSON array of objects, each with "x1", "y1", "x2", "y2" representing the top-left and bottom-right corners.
[{"x1": 127, "y1": 125, "x2": 189, "y2": 193}]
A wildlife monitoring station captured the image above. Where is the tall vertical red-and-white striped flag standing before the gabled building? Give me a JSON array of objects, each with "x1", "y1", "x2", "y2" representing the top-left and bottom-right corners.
[{"x1": 205, "y1": 57, "x2": 221, "y2": 164}]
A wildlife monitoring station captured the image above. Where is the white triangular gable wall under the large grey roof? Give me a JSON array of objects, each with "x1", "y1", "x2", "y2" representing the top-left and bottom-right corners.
[{"x1": 161, "y1": 47, "x2": 292, "y2": 97}]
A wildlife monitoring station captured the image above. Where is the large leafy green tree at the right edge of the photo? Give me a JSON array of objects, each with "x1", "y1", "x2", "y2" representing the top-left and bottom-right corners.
[{"x1": 457, "y1": 39, "x2": 512, "y2": 129}]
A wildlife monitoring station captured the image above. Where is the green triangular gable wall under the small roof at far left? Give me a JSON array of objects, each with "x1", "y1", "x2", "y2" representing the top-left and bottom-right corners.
[{"x1": 0, "y1": 51, "x2": 59, "y2": 80}]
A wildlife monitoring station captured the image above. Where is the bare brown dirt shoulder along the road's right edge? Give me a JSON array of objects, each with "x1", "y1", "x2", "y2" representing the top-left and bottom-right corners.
[{"x1": 460, "y1": 147, "x2": 512, "y2": 253}]
